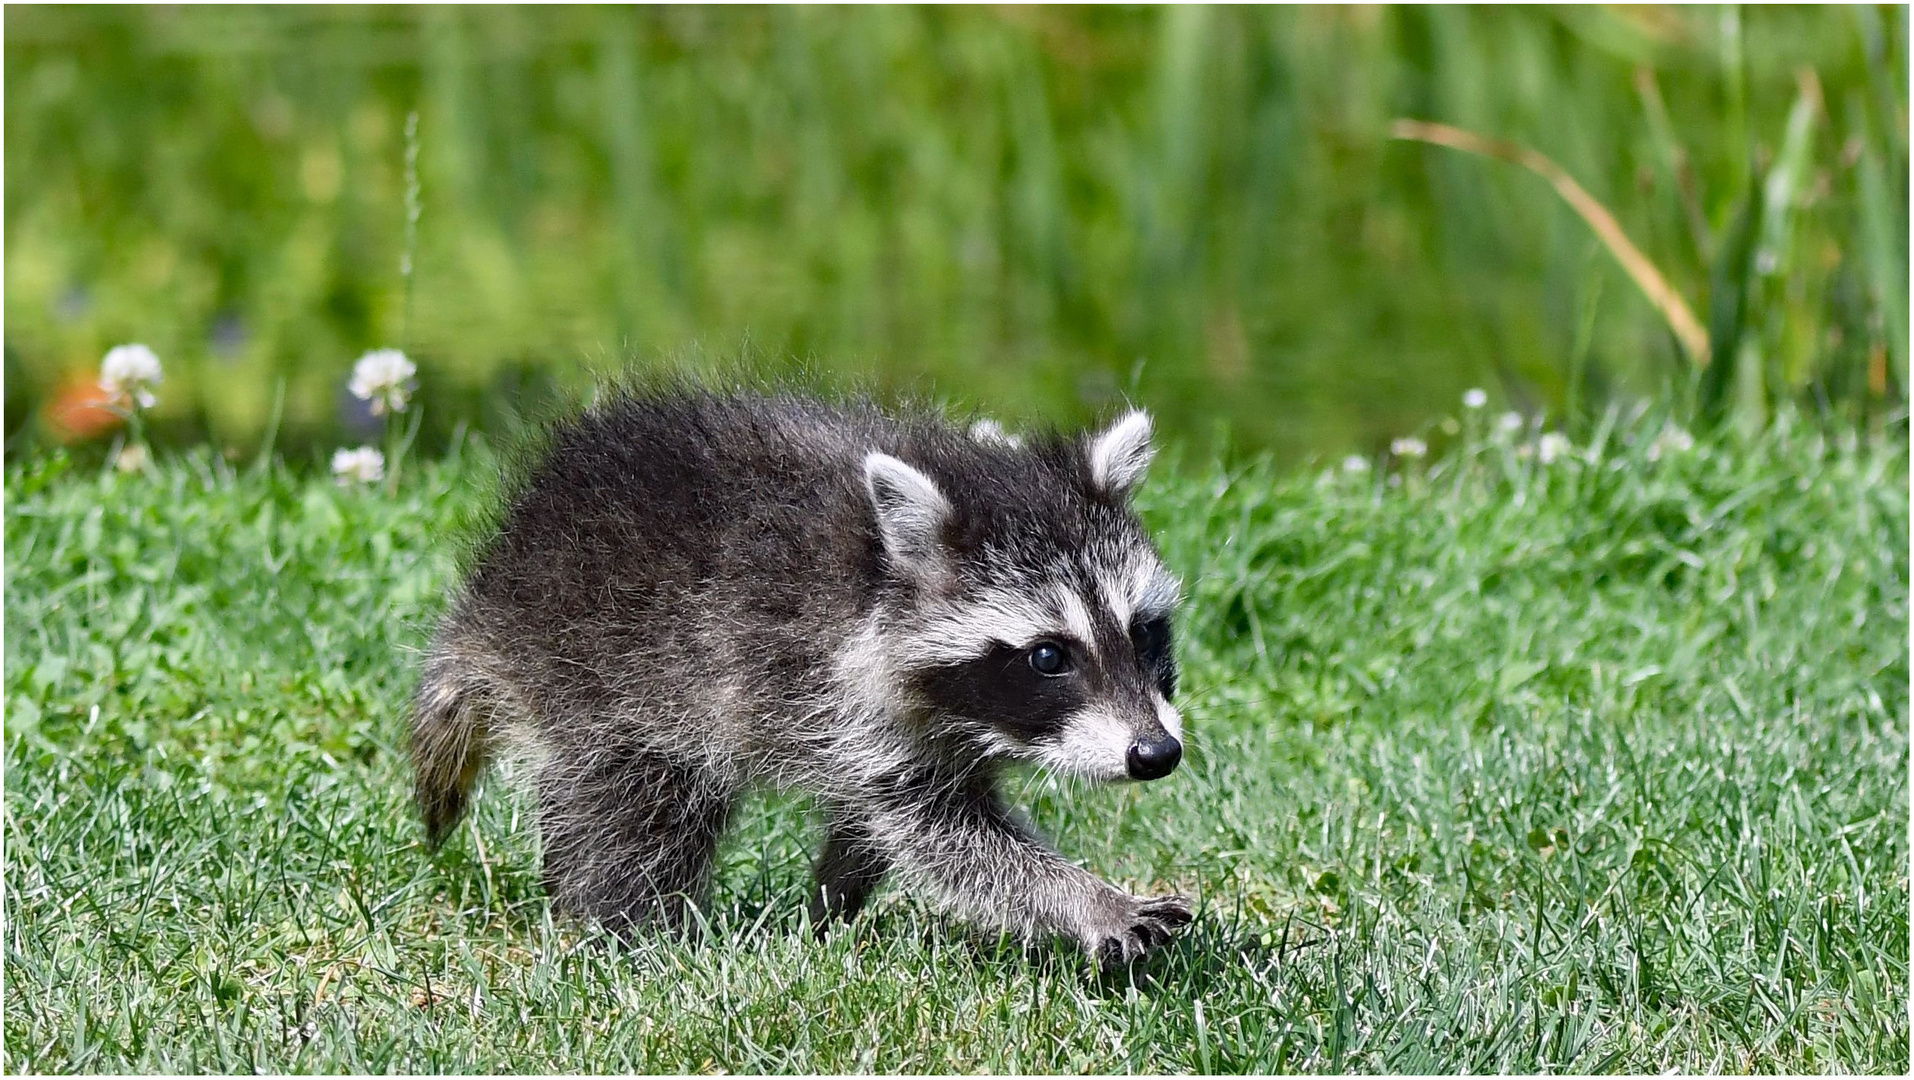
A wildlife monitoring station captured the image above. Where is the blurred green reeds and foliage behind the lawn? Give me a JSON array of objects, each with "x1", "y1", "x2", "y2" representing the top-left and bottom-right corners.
[{"x1": 6, "y1": 6, "x2": 1908, "y2": 458}]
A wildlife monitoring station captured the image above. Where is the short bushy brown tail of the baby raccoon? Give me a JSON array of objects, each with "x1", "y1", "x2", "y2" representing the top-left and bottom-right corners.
[{"x1": 412, "y1": 647, "x2": 492, "y2": 848}]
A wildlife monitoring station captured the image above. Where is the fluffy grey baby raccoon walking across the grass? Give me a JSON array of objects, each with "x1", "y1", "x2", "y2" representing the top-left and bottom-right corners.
[{"x1": 412, "y1": 391, "x2": 1191, "y2": 965}]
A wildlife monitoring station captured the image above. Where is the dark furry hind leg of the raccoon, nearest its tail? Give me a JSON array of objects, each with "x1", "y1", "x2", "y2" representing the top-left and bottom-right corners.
[{"x1": 538, "y1": 747, "x2": 733, "y2": 938}]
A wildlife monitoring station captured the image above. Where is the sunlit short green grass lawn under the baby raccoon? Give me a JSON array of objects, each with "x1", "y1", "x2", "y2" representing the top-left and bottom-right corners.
[{"x1": 4, "y1": 416, "x2": 1908, "y2": 1074}]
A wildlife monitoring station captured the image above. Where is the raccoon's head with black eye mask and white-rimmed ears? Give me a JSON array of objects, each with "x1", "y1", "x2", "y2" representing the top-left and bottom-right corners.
[{"x1": 863, "y1": 412, "x2": 1183, "y2": 779}]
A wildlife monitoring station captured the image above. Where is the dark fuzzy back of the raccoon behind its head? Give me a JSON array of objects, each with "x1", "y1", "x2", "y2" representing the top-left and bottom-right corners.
[{"x1": 465, "y1": 393, "x2": 896, "y2": 674}]
